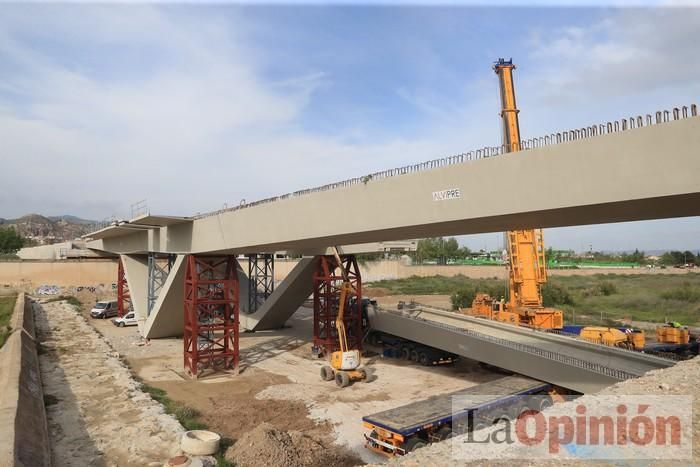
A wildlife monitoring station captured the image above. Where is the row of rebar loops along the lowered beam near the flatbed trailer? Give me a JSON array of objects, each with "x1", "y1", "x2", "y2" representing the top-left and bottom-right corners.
[{"x1": 382, "y1": 309, "x2": 640, "y2": 381}]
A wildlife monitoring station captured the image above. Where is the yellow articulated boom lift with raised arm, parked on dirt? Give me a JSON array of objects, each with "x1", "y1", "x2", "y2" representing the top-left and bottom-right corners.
[{"x1": 321, "y1": 248, "x2": 367, "y2": 388}]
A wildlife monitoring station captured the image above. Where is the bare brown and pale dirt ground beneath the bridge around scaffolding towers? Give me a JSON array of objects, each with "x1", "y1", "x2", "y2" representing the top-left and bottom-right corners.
[{"x1": 80, "y1": 292, "x2": 498, "y2": 464}]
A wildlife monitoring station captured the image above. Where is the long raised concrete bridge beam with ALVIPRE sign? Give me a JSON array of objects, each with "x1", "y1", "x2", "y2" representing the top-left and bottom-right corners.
[{"x1": 90, "y1": 117, "x2": 700, "y2": 253}]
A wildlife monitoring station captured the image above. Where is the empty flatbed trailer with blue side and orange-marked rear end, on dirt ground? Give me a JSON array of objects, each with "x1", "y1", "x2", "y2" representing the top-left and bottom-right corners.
[{"x1": 362, "y1": 376, "x2": 556, "y2": 456}]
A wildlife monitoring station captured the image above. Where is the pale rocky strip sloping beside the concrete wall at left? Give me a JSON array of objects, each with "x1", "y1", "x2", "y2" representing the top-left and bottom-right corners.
[{"x1": 34, "y1": 302, "x2": 184, "y2": 466}]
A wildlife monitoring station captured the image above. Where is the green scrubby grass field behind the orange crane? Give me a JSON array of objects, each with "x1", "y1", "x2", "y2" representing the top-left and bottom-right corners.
[{"x1": 367, "y1": 273, "x2": 700, "y2": 326}]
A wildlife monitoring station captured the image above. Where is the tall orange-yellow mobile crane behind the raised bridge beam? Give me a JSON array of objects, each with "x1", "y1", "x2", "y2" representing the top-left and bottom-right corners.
[{"x1": 470, "y1": 59, "x2": 564, "y2": 329}]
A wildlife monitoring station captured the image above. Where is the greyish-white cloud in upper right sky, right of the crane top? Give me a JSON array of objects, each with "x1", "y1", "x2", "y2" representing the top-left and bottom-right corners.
[{"x1": 528, "y1": 8, "x2": 700, "y2": 111}]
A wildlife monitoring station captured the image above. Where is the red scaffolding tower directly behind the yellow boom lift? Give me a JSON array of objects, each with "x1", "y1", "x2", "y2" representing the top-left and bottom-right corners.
[{"x1": 314, "y1": 255, "x2": 362, "y2": 355}]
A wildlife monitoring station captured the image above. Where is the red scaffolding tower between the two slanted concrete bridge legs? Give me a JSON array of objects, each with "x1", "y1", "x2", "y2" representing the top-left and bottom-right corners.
[{"x1": 183, "y1": 255, "x2": 239, "y2": 378}]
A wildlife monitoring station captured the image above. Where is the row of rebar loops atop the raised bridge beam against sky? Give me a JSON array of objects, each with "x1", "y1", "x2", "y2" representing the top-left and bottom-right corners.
[{"x1": 193, "y1": 104, "x2": 698, "y2": 219}]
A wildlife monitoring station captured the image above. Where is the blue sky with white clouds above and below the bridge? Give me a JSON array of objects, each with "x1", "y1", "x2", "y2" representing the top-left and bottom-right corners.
[{"x1": 0, "y1": 2, "x2": 700, "y2": 251}]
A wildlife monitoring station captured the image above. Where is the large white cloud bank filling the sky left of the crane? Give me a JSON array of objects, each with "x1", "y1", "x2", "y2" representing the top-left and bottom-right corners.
[{"x1": 0, "y1": 6, "x2": 497, "y2": 217}]
